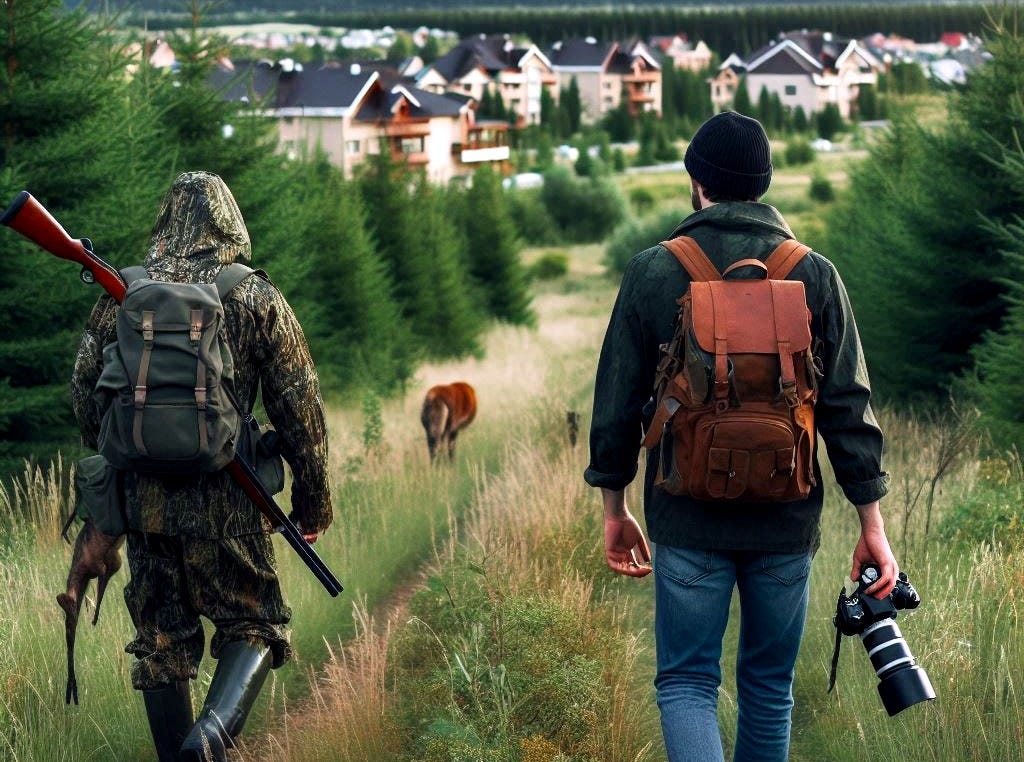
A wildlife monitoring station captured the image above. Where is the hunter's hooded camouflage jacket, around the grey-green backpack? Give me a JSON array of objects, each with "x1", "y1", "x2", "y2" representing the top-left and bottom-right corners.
[{"x1": 72, "y1": 173, "x2": 332, "y2": 539}]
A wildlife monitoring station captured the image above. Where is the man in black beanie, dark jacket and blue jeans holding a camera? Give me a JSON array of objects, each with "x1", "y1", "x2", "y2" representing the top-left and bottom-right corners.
[{"x1": 585, "y1": 112, "x2": 898, "y2": 762}]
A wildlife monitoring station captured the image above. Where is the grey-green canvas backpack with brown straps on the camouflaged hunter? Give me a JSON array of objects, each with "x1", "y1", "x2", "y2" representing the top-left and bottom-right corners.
[{"x1": 95, "y1": 263, "x2": 255, "y2": 473}]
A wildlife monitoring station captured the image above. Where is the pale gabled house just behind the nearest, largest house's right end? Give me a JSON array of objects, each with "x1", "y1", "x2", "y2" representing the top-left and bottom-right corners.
[{"x1": 416, "y1": 35, "x2": 558, "y2": 125}]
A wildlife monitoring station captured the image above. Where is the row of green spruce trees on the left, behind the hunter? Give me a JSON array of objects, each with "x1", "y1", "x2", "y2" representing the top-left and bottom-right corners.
[{"x1": 0, "y1": 0, "x2": 534, "y2": 473}]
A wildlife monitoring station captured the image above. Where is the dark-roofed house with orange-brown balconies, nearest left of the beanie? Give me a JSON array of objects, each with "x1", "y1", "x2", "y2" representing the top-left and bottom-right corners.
[{"x1": 548, "y1": 37, "x2": 662, "y2": 123}]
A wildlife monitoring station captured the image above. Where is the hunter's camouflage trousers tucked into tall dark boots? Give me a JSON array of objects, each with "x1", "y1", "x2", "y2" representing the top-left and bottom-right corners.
[{"x1": 125, "y1": 532, "x2": 292, "y2": 690}]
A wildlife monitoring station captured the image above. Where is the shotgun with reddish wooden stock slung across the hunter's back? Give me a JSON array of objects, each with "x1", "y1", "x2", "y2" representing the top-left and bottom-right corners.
[{"x1": 0, "y1": 191, "x2": 343, "y2": 596}]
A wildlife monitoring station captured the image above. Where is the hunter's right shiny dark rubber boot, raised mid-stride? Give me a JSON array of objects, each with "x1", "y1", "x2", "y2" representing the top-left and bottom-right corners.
[{"x1": 180, "y1": 640, "x2": 273, "y2": 762}]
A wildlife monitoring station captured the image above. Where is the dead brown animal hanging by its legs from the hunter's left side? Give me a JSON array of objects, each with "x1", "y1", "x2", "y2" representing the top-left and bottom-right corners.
[{"x1": 57, "y1": 513, "x2": 125, "y2": 704}]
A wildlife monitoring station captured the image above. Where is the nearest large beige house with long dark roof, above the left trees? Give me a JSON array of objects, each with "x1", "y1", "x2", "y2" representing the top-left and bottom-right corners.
[{"x1": 213, "y1": 61, "x2": 509, "y2": 183}]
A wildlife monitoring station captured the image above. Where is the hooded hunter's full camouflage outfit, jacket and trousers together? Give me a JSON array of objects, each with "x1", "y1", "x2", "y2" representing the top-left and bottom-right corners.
[{"x1": 72, "y1": 172, "x2": 332, "y2": 759}]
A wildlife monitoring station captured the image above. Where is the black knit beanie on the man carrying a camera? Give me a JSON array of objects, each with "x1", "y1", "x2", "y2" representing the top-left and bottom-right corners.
[{"x1": 683, "y1": 112, "x2": 771, "y2": 201}]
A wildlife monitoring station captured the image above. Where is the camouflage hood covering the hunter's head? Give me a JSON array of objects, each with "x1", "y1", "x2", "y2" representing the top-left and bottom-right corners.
[{"x1": 145, "y1": 172, "x2": 251, "y2": 283}]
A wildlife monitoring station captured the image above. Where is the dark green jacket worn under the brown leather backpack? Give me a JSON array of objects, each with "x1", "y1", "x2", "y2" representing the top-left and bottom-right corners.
[{"x1": 585, "y1": 202, "x2": 889, "y2": 553}]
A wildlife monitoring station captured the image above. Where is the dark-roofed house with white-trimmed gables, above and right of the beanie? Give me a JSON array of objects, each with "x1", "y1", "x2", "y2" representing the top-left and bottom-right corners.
[{"x1": 711, "y1": 31, "x2": 882, "y2": 119}]
